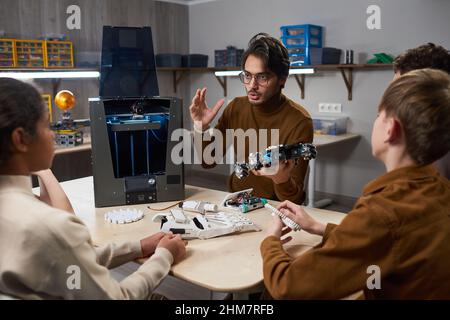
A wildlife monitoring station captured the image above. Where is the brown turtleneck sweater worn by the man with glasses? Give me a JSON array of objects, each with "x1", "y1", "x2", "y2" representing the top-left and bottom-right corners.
[{"x1": 203, "y1": 94, "x2": 313, "y2": 204}]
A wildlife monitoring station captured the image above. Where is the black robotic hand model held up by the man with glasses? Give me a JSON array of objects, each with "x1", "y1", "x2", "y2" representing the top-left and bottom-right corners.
[{"x1": 234, "y1": 143, "x2": 317, "y2": 179}]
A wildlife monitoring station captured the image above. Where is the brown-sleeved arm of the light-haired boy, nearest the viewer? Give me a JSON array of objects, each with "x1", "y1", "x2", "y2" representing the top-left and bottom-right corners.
[{"x1": 261, "y1": 200, "x2": 394, "y2": 299}]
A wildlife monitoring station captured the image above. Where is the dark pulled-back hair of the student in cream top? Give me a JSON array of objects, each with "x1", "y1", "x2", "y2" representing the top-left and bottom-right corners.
[{"x1": 0, "y1": 78, "x2": 45, "y2": 165}]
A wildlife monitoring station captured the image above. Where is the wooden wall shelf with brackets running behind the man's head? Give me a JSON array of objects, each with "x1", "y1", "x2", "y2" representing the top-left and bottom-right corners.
[{"x1": 157, "y1": 64, "x2": 393, "y2": 100}]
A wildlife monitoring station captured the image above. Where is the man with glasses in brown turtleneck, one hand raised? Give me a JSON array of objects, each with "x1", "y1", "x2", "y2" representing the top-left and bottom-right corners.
[{"x1": 189, "y1": 34, "x2": 313, "y2": 204}]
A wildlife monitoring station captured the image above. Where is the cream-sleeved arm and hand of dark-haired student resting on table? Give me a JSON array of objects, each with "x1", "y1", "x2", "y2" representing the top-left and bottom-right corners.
[{"x1": 44, "y1": 215, "x2": 186, "y2": 299}]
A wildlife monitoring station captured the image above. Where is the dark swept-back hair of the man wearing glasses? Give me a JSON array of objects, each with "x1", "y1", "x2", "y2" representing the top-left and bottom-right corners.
[{"x1": 242, "y1": 33, "x2": 290, "y2": 79}]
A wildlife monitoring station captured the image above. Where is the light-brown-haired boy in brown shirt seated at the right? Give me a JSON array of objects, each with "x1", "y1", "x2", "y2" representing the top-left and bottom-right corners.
[{"x1": 261, "y1": 69, "x2": 450, "y2": 299}]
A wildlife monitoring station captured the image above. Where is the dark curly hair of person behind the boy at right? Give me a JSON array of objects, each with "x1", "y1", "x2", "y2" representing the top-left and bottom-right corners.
[{"x1": 394, "y1": 43, "x2": 450, "y2": 74}]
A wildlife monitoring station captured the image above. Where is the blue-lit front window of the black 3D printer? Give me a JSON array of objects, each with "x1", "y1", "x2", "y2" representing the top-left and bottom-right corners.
[{"x1": 106, "y1": 100, "x2": 170, "y2": 178}]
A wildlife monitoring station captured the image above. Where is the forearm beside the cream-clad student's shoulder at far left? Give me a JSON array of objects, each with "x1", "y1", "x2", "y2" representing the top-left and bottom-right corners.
[{"x1": 33, "y1": 169, "x2": 75, "y2": 213}]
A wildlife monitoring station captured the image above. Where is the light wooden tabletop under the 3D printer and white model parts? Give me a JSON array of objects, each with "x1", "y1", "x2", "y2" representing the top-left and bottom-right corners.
[{"x1": 56, "y1": 177, "x2": 345, "y2": 297}]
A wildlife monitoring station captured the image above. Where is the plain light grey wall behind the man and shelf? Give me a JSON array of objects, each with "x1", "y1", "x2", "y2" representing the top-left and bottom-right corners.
[{"x1": 189, "y1": 0, "x2": 450, "y2": 197}]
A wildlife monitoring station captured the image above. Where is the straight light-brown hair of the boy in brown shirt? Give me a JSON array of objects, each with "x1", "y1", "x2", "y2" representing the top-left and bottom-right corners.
[{"x1": 378, "y1": 69, "x2": 450, "y2": 165}]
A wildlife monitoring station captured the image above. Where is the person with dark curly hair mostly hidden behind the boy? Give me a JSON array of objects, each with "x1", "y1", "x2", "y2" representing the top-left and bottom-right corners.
[{"x1": 394, "y1": 43, "x2": 450, "y2": 180}]
